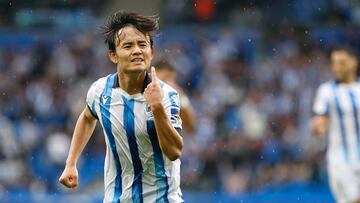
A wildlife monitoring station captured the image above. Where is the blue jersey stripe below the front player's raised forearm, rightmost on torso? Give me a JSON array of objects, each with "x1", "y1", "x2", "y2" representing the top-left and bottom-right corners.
[{"x1": 146, "y1": 120, "x2": 169, "y2": 203}]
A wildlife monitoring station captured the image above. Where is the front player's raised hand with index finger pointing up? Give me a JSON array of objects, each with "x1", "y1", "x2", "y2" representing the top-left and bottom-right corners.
[{"x1": 144, "y1": 67, "x2": 164, "y2": 111}]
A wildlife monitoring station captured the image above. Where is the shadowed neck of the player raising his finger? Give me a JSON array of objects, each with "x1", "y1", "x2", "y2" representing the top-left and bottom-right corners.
[{"x1": 118, "y1": 72, "x2": 146, "y2": 95}]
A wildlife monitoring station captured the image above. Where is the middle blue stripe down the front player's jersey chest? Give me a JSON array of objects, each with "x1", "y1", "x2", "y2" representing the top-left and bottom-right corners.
[{"x1": 122, "y1": 96, "x2": 143, "y2": 203}]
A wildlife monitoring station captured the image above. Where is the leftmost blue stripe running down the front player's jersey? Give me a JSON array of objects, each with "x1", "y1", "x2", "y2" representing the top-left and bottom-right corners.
[{"x1": 100, "y1": 74, "x2": 122, "y2": 203}]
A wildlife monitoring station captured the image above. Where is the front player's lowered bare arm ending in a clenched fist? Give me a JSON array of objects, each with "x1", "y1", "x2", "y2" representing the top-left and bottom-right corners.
[{"x1": 59, "y1": 106, "x2": 97, "y2": 188}]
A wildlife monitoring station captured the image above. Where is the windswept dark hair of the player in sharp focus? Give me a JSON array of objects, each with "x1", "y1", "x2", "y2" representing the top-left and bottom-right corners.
[{"x1": 103, "y1": 11, "x2": 159, "y2": 51}]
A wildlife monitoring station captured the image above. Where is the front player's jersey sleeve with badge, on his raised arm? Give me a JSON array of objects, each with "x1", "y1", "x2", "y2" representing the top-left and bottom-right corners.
[{"x1": 164, "y1": 91, "x2": 182, "y2": 131}]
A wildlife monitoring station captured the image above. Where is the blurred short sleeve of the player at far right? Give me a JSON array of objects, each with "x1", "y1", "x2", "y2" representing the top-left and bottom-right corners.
[{"x1": 313, "y1": 84, "x2": 330, "y2": 115}]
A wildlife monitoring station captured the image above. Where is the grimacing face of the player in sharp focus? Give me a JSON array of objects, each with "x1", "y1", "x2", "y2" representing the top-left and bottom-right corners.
[{"x1": 109, "y1": 26, "x2": 154, "y2": 73}]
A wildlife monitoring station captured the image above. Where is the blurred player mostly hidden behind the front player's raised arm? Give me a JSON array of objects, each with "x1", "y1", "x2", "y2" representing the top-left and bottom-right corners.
[{"x1": 154, "y1": 58, "x2": 195, "y2": 134}]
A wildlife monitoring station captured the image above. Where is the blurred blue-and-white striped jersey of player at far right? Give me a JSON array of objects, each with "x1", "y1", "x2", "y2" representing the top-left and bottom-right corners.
[{"x1": 313, "y1": 81, "x2": 360, "y2": 165}]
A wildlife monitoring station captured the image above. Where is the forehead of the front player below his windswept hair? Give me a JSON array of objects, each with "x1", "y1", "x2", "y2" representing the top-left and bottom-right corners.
[{"x1": 117, "y1": 26, "x2": 150, "y2": 44}]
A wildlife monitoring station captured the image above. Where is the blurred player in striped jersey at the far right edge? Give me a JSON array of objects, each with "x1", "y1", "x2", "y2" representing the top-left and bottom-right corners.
[{"x1": 311, "y1": 47, "x2": 360, "y2": 203}]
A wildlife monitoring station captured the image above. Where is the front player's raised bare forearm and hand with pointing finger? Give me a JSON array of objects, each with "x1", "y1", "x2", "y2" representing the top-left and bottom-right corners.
[{"x1": 144, "y1": 67, "x2": 183, "y2": 161}]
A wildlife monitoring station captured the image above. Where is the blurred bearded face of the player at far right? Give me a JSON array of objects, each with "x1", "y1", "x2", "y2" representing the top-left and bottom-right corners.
[{"x1": 331, "y1": 50, "x2": 357, "y2": 82}]
